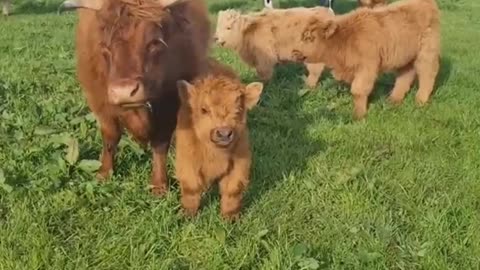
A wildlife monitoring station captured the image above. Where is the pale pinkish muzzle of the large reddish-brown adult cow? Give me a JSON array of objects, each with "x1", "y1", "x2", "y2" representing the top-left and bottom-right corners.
[{"x1": 108, "y1": 79, "x2": 145, "y2": 105}]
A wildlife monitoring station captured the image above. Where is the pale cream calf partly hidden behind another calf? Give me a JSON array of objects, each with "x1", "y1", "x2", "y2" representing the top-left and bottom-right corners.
[{"x1": 215, "y1": 7, "x2": 333, "y2": 87}]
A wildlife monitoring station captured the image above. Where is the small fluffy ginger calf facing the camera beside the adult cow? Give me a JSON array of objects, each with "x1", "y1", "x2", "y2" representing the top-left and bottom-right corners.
[{"x1": 175, "y1": 66, "x2": 263, "y2": 219}]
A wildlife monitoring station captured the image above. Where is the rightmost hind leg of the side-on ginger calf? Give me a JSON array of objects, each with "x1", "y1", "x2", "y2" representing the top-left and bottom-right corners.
[{"x1": 415, "y1": 30, "x2": 440, "y2": 106}]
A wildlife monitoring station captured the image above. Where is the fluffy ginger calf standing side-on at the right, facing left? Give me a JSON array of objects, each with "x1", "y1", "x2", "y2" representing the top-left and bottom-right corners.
[{"x1": 302, "y1": 0, "x2": 440, "y2": 119}]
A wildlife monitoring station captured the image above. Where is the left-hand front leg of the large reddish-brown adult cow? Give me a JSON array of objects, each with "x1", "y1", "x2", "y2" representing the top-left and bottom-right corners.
[{"x1": 97, "y1": 117, "x2": 122, "y2": 180}]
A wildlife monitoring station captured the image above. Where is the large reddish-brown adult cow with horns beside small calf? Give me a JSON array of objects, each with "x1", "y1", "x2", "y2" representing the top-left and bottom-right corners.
[{"x1": 58, "y1": 0, "x2": 211, "y2": 195}]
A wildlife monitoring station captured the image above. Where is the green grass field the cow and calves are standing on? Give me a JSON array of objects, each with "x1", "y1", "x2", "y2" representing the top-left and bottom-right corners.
[{"x1": 0, "y1": 0, "x2": 480, "y2": 270}]
